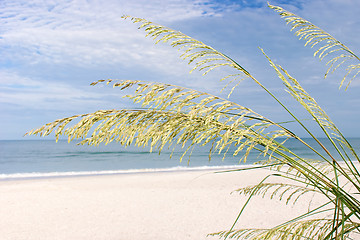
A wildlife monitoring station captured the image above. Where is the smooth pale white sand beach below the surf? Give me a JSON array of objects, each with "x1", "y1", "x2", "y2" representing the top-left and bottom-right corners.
[{"x1": 0, "y1": 170, "x2": 326, "y2": 240}]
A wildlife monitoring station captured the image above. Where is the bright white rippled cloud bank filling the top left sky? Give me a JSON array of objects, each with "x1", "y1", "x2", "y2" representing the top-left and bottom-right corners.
[{"x1": 0, "y1": 0, "x2": 226, "y2": 66}]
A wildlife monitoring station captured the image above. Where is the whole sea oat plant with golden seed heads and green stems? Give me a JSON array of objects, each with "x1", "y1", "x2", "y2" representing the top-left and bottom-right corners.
[{"x1": 27, "y1": 4, "x2": 360, "y2": 239}]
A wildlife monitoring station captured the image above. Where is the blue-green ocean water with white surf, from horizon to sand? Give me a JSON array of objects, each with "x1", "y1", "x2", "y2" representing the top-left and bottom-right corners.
[{"x1": 0, "y1": 138, "x2": 360, "y2": 179}]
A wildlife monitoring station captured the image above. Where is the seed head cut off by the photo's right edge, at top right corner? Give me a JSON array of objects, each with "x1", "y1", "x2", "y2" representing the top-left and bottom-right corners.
[{"x1": 268, "y1": 4, "x2": 360, "y2": 89}]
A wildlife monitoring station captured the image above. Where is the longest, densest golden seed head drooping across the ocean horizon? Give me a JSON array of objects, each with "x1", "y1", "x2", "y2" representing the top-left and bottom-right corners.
[{"x1": 24, "y1": 110, "x2": 272, "y2": 162}]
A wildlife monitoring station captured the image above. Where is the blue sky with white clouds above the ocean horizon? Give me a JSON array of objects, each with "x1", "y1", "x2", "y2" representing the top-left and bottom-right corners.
[{"x1": 0, "y1": 0, "x2": 360, "y2": 139}]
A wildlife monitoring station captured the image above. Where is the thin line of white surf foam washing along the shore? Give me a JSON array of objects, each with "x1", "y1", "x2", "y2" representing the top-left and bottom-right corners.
[{"x1": 0, "y1": 165, "x2": 246, "y2": 180}]
